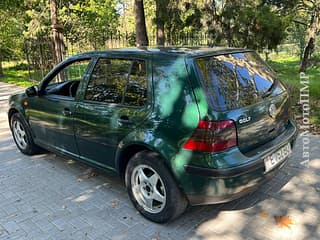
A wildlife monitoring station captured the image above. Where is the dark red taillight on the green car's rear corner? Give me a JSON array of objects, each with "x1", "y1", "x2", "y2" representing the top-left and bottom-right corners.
[{"x1": 183, "y1": 120, "x2": 237, "y2": 152}]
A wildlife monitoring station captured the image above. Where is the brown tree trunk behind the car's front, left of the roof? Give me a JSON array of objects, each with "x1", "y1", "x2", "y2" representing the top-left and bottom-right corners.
[{"x1": 50, "y1": 0, "x2": 64, "y2": 64}]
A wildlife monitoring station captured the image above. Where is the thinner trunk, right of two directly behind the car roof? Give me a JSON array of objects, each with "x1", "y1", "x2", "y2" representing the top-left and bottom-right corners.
[{"x1": 156, "y1": 0, "x2": 169, "y2": 46}]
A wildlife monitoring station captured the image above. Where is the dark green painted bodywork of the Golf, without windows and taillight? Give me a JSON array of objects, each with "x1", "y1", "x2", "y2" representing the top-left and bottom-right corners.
[{"x1": 10, "y1": 48, "x2": 296, "y2": 202}]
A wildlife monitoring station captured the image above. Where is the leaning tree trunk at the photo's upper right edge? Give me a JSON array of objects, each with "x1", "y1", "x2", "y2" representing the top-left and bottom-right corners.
[{"x1": 299, "y1": 11, "x2": 320, "y2": 72}]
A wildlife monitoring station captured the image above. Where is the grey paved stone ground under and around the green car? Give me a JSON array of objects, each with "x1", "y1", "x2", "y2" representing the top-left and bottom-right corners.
[{"x1": 0, "y1": 83, "x2": 320, "y2": 240}]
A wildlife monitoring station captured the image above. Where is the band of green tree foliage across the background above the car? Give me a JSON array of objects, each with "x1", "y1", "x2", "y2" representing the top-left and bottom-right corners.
[{"x1": 0, "y1": 0, "x2": 320, "y2": 72}]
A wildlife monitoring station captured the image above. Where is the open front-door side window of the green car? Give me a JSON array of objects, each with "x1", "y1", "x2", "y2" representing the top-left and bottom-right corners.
[{"x1": 46, "y1": 59, "x2": 90, "y2": 97}]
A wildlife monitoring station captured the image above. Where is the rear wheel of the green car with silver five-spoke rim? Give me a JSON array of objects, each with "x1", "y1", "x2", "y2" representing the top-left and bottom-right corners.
[{"x1": 125, "y1": 151, "x2": 187, "y2": 223}]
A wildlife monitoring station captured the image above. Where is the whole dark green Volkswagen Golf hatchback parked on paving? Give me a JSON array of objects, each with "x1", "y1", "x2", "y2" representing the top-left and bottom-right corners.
[{"x1": 8, "y1": 48, "x2": 297, "y2": 223}]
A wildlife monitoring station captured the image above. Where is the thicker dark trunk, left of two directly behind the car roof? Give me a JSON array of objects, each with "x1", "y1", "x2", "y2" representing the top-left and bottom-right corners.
[{"x1": 134, "y1": 0, "x2": 148, "y2": 47}]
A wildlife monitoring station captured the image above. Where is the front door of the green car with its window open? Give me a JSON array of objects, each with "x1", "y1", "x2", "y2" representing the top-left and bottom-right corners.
[{"x1": 27, "y1": 58, "x2": 90, "y2": 156}]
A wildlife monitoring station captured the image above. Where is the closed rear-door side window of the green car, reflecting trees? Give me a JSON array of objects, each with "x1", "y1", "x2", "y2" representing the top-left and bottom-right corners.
[{"x1": 85, "y1": 58, "x2": 147, "y2": 106}]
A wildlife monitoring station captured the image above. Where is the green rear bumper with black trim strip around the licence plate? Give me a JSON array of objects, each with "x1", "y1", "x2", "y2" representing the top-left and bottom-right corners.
[{"x1": 180, "y1": 119, "x2": 297, "y2": 205}]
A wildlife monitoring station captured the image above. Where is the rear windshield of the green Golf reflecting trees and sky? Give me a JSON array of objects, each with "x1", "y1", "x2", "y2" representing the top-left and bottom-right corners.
[{"x1": 196, "y1": 52, "x2": 284, "y2": 111}]
